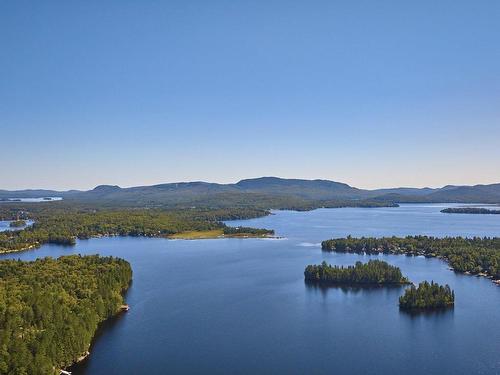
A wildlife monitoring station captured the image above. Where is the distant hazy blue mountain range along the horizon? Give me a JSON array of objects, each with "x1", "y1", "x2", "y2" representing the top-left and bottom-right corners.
[{"x1": 0, "y1": 177, "x2": 500, "y2": 208}]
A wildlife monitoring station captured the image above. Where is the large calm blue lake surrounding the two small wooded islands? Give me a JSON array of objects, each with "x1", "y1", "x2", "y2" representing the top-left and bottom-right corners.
[{"x1": 0, "y1": 205, "x2": 500, "y2": 375}]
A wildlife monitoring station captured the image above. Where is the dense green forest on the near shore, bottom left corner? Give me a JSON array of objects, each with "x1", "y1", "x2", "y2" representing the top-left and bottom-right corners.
[{"x1": 0, "y1": 255, "x2": 132, "y2": 375}]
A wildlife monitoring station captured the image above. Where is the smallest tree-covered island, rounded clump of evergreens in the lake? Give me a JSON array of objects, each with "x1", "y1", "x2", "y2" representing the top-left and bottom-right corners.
[{"x1": 399, "y1": 281, "x2": 455, "y2": 310}]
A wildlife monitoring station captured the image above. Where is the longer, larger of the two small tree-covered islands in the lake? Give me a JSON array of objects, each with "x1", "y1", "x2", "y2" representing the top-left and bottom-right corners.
[{"x1": 304, "y1": 260, "x2": 409, "y2": 285}]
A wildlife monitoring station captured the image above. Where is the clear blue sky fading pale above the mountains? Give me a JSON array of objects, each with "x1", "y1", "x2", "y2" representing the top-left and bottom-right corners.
[{"x1": 0, "y1": 0, "x2": 500, "y2": 189}]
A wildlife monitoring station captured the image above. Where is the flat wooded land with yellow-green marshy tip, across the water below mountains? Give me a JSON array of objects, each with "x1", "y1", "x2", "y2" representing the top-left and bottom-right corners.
[{"x1": 0, "y1": 203, "x2": 272, "y2": 252}]
